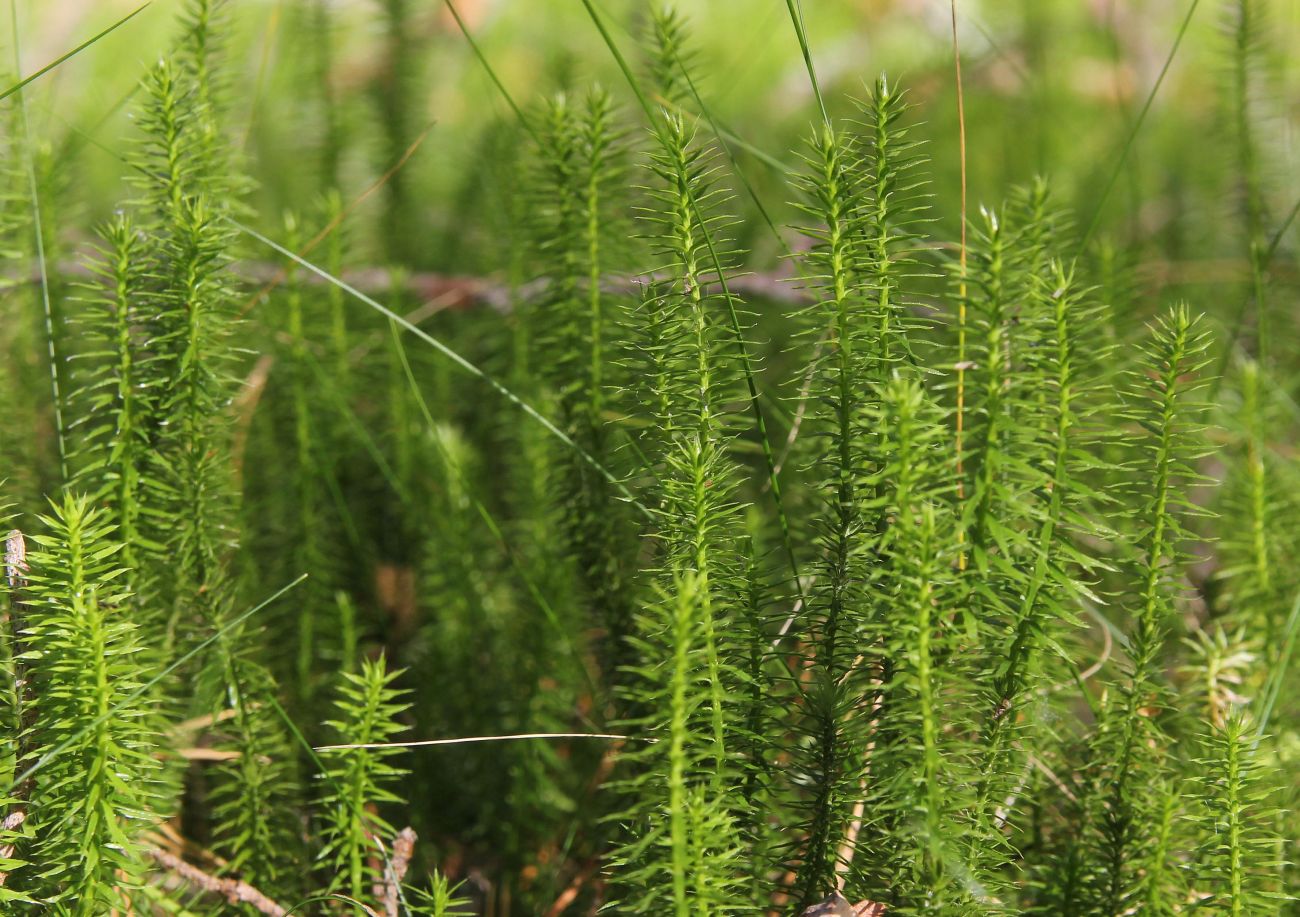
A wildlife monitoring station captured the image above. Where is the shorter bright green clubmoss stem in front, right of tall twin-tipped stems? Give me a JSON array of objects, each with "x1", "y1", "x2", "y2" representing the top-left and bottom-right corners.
[{"x1": 854, "y1": 380, "x2": 982, "y2": 913}]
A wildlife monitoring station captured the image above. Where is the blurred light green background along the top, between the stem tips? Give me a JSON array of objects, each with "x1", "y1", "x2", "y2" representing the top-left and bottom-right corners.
[{"x1": 16, "y1": 0, "x2": 1300, "y2": 293}]
